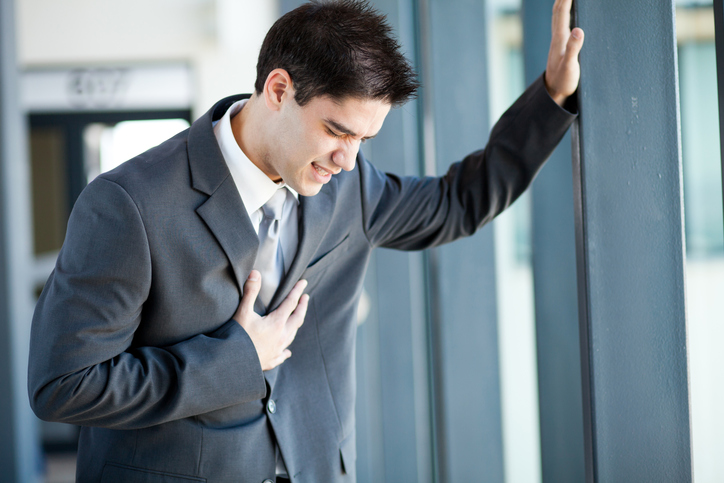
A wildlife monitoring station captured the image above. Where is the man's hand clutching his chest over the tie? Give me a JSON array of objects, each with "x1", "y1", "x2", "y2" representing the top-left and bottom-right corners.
[{"x1": 234, "y1": 270, "x2": 309, "y2": 371}]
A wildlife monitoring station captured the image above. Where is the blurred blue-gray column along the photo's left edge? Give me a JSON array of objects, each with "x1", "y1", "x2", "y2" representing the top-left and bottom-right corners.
[{"x1": 0, "y1": 0, "x2": 39, "y2": 483}]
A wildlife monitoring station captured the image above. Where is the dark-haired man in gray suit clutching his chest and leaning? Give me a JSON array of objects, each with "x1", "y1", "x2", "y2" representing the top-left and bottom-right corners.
[{"x1": 29, "y1": 0, "x2": 583, "y2": 482}]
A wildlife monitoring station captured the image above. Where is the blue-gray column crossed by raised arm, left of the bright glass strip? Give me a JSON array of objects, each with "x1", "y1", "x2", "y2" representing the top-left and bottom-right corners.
[{"x1": 419, "y1": 0, "x2": 504, "y2": 483}]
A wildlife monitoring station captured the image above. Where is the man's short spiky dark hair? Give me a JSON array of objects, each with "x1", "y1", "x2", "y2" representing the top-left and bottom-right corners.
[{"x1": 254, "y1": 0, "x2": 418, "y2": 106}]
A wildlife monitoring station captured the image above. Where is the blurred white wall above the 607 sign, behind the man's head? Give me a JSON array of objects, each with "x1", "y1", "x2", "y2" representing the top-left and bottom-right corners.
[{"x1": 16, "y1": 0, "x2": 278, "y2": 117}]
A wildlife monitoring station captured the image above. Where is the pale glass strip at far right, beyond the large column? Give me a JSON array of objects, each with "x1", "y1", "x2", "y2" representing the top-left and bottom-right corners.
[{"x1": 676, "y1": 1, "x2": 724, "y2": 482}]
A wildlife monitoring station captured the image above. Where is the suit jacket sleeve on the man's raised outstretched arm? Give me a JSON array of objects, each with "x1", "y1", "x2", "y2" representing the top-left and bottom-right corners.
[{"x1": 359, "y1": 76, "x2": 576, "y2": 250}]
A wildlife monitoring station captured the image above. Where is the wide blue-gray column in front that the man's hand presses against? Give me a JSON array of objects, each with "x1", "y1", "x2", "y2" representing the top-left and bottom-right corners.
[{"x1": 574, "y1": 0, "x2": 692, "y2": 482}]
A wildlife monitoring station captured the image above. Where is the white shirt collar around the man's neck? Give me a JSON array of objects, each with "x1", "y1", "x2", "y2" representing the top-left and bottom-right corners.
[{"x1": 214, "y1": 99, "x2": 299, "y2": 216}]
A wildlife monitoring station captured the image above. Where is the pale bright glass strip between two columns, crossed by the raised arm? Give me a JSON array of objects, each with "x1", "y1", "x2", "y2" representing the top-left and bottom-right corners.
[{"x1": 488, "y1": 0, "x2": 541, "y2": 483}]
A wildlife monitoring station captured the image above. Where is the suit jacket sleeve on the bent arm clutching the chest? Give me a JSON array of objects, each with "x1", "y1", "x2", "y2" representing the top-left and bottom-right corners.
[{"x1": 28, "y1": 178, "x2": 266, "y2": 429}]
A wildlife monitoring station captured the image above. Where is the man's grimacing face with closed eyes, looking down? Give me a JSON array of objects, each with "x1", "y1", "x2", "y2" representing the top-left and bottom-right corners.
[{"x1": 263, "y1": 97, "x2": 390, "y2": 196}]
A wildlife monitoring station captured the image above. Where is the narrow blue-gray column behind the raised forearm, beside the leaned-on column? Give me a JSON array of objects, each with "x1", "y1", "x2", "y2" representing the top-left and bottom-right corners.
[{"x1": 523, "y1": 0, "x2": 585, "y2": 483}]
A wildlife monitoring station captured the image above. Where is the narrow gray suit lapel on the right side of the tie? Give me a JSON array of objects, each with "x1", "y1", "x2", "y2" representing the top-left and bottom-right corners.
[{"x1": 269, "y1": 178, "x2": 337, "y2": 310}]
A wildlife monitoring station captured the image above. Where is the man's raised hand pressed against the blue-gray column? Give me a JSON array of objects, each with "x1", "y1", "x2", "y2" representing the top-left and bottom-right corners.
[{"x1": 545, "y1": 0, "x2": 583, "y2": 106}]
